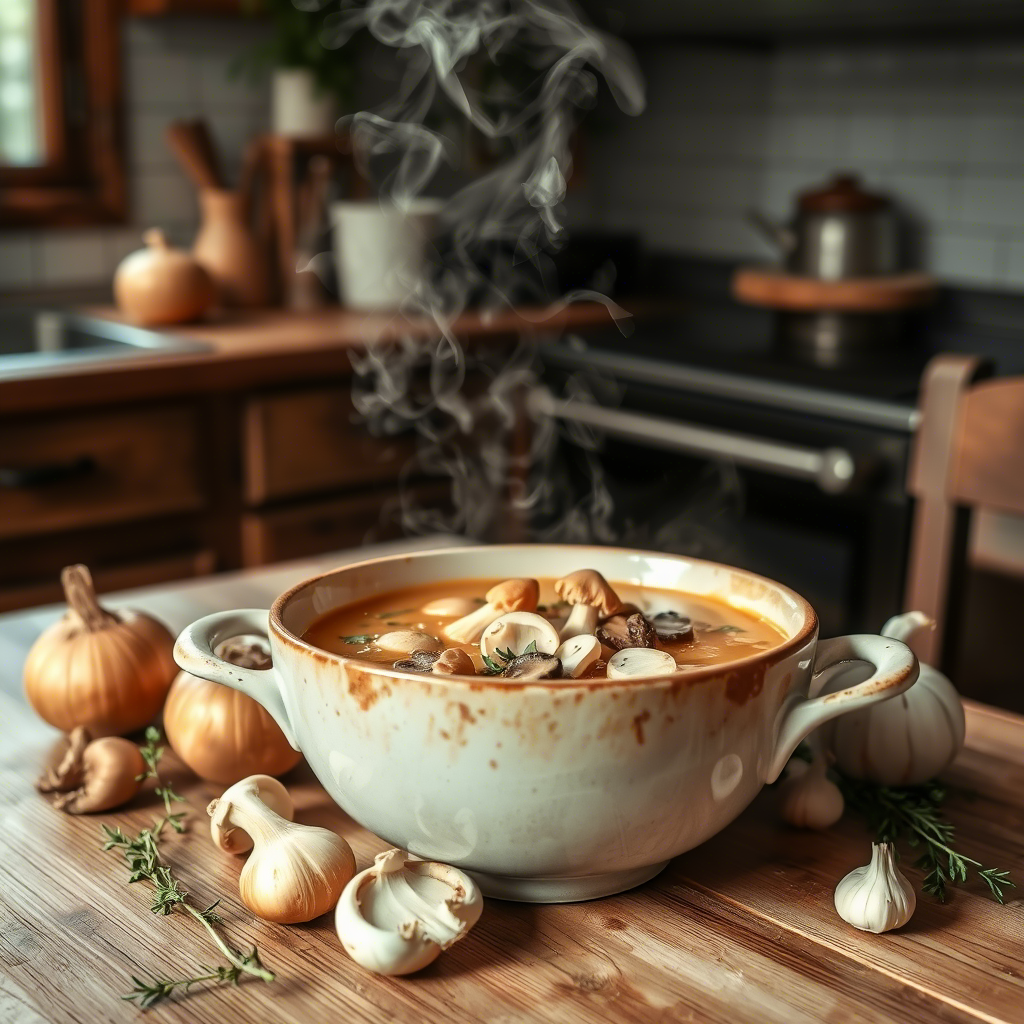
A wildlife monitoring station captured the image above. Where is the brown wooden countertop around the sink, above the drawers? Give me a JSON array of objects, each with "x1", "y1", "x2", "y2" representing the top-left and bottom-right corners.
[{"x1": 0, "y1": 302, "x2": 638, "y2": 415}]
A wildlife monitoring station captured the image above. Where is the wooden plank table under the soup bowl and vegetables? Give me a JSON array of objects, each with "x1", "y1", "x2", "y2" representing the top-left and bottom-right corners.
[{"x1": 0, "y1": 546, "x2": 1024, "y2": 1024}]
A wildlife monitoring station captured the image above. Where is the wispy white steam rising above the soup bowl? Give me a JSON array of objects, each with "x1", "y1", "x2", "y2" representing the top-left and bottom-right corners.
[{"x1": 329, "y1": 0, "x2": 644, "y2": 540}]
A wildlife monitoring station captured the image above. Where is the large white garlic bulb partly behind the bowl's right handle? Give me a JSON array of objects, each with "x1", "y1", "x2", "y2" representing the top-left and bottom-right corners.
[{"x1": 822, "y1": 611, "x2": 965, "y2": 785}]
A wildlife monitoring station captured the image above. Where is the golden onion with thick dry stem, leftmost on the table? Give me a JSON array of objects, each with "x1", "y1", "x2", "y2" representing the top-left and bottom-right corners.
[{"x1": 25, "y1": 565, "x2": 176, "y2": 737}]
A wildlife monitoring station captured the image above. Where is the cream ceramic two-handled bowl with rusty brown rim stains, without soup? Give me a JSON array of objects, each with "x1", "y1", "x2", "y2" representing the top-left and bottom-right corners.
[{"x1": 175, "y1": 545, "x2": 918, "y2": 902}]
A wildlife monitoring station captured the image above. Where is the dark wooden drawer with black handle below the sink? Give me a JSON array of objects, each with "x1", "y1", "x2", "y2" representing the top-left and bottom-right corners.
[{"x1": 0, "y1": 408, "x2": 203, "y2": 538}]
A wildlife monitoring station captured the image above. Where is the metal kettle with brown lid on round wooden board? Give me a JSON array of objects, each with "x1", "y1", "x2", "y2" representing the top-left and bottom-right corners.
[{"x1": 750, "y1": 174, "x2": 899, "y2": 281}]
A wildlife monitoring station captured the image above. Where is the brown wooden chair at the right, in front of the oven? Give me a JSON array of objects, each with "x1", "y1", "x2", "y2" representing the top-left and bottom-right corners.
[{"x1": 904, "y1": 355, "x2": 1024, "y2": 666}]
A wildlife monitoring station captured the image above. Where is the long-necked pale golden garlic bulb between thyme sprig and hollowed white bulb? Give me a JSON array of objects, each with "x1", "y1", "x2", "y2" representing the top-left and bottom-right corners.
[{"x1": 207, "y1": 775, "x2": 355, "y2": 925}]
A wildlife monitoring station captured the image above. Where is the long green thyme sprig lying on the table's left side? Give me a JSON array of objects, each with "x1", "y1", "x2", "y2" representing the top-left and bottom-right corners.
[{"x1": 102, "y1": 726, "x2": 274, "y2": 1008}]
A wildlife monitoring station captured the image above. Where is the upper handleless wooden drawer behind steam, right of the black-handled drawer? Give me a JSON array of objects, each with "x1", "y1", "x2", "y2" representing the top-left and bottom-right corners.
[{"x1": 243, "y1": 388, "x2": 415, "y2": 505}]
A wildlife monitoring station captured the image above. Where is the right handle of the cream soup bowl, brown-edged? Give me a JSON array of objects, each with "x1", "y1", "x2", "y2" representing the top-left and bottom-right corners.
[{"x1": 765, "y1": 633, "x2": 920, "y2": 782}]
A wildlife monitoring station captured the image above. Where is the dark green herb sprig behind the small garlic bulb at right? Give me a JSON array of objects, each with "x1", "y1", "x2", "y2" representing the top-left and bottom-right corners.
[{"x1": 837, "y1": 773, "x2": 1016, "y2": 903}]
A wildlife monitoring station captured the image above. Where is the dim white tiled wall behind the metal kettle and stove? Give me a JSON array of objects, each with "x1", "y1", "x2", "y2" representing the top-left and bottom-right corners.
[{"x1": 591, "y1": 39, "x2": 1024, "y2": 289}]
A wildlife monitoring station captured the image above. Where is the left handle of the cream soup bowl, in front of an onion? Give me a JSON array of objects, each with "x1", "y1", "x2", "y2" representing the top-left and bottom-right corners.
[{"x1": 174, "y1": 608, "x2": 299, "y2": 750}]
